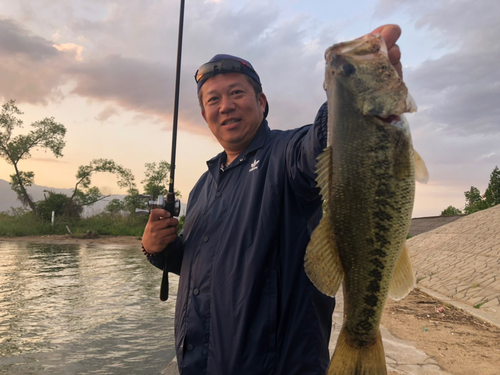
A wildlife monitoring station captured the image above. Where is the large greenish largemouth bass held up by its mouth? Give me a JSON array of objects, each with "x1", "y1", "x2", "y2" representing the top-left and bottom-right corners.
[{"x1": 305, "y1": 35, "x2": 428, "y2": 375}]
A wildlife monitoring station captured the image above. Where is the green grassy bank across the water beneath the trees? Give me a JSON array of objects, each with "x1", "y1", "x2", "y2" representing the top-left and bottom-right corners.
[{"x1": 0, "y1": 212, "x2": 148, "y2": 237}]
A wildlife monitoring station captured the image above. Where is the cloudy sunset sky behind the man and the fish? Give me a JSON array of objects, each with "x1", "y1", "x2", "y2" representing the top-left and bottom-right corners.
[{"x1": 0, "y1": 0, "x2": 500, "y2": 217}]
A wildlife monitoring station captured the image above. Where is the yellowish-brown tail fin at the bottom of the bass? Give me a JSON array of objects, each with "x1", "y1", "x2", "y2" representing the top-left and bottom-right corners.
[{"x1": 326, "y1": 327, "x2": 387, "y2": 375}]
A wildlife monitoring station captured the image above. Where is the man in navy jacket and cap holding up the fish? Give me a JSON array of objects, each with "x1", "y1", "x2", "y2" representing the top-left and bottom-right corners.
[{"x1": 143, "y1": 25, "x2": 401, "y2": 375}]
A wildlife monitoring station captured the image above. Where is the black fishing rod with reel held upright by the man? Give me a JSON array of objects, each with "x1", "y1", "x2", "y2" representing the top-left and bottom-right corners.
[{"x1": 136, "y1": 0, "x2": 184, "y2": 301}]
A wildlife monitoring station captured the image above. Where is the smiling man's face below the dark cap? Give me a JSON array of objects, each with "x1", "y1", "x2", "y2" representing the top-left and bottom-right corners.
[{"x1": 201, "y1": 73, "x2": 266, "y2": 153}]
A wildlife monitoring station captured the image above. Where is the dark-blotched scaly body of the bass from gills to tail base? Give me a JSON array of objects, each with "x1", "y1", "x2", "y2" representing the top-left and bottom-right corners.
[{"x1": 328, "y1": 117, "x2": 415, "y2": 345}]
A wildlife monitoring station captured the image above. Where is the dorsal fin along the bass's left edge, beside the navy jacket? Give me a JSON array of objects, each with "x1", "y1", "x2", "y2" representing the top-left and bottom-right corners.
[{"x1": 304, "y1": 147, "x2": 344, "y2": 297}]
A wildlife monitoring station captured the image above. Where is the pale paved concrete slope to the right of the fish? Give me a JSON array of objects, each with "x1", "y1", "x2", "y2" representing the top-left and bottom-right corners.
[{"x1": 408, "y1": 205, "x2": 500, "y2": 322}]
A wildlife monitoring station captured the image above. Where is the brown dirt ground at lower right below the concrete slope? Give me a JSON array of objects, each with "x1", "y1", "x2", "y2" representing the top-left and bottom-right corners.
[{"x1": 382, "y1": 289, "x2": 500, "y2": 375}]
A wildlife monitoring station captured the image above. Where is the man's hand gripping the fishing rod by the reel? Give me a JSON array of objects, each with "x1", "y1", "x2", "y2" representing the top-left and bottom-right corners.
[{"x1": 142, "y1": 208, "x2": 179, "y2": 254}]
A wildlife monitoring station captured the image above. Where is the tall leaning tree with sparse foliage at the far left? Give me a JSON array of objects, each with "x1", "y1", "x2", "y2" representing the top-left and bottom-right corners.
[{"x1": 0, "y1": 100, "x2": 66, "y2": 216}]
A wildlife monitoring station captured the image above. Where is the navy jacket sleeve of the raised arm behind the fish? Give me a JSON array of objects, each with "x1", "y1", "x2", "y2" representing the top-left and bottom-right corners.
[{"x1": 286, "y1": 102, "x2": 328, "y2": 205}]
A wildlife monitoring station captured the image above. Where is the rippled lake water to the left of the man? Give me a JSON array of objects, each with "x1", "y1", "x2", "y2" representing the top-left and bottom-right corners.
[{"x1": 0, "y1": 241, "x2": 178, "y2": 375}]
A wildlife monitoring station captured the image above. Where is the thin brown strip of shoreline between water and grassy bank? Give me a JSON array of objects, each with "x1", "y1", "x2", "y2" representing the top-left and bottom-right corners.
[{"x1": 0, "y1": 234, "x2": 141, "y2": 248}]
